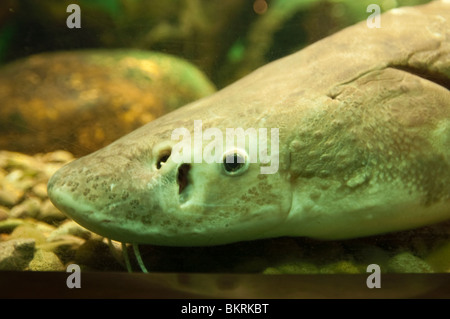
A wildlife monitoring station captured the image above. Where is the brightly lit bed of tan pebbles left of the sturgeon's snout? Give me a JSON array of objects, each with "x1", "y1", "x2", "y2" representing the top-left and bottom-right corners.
[{"x1": 0, "y1": 151, "x2": 107, "y2": 271}]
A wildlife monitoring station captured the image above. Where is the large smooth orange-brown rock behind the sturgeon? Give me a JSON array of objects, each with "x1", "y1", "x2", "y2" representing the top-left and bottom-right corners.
[{"x1": 0, "y1": 50, "x2": 215, "y2": 158}]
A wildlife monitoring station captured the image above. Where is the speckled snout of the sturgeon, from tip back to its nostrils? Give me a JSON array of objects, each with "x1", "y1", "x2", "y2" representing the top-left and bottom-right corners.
[{"x1": 47, "y1": 142, "x2": 196, "y2": 242}]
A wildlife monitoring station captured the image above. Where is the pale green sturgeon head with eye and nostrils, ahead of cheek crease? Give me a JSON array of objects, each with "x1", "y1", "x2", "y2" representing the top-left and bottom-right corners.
[{"x1": 48, "y1": 107, "x2": 291, "y2": 246}]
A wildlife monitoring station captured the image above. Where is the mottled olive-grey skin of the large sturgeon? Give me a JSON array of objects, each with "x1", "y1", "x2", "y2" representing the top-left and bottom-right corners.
[{"x1": 48, "y1": 0, "x2": 450, "y2": 246}]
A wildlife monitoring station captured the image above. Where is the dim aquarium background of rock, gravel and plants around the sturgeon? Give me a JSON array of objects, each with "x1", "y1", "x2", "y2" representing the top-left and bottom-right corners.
[{"x1": 0, "y1": 0, "x2": 450, "y2": 288}]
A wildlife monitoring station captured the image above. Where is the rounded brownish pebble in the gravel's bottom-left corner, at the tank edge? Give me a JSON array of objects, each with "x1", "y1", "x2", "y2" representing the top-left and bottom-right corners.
[{"x1": 0, "y1": 238, "x2": 35, "y2": 270}]
